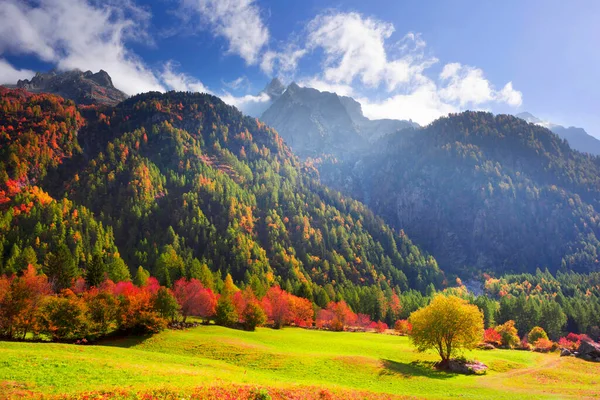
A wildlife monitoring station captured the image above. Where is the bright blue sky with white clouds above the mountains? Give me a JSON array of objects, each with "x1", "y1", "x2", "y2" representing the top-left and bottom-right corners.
[{"x1": 0, "y1": 0, "x2": 600, "y2": 136}]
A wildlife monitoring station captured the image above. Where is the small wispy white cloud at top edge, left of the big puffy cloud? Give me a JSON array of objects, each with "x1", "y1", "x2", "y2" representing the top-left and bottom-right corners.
[{"x1": 182, "y1": 0, "x2": 269, "y2": 65}]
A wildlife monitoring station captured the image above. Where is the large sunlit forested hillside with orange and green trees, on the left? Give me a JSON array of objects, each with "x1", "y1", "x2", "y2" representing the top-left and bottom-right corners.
[{"x1": 0, "y1": 90, "x2": 443, "y2": 316}]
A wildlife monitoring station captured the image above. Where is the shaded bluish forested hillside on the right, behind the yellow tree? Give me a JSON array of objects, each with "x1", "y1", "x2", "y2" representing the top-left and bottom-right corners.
[{"x1": 319, "y1": 112, "x2": 600, "y2": 276}]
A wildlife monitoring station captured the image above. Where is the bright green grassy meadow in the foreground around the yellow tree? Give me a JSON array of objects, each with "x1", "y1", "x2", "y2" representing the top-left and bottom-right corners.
[{"x1": 0, "y1": 326, "x2": 600, "y2": 399}]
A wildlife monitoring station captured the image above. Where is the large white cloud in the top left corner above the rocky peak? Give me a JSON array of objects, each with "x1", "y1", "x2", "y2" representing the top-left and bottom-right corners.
[{"x1": 0, "y1": 0, "x2": 164, "y2": 94}]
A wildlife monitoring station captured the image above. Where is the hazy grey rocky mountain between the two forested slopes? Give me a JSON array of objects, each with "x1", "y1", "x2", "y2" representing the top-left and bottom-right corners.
[{"x1": 261, "y1": 83, "x2": 418, "y2": 158}]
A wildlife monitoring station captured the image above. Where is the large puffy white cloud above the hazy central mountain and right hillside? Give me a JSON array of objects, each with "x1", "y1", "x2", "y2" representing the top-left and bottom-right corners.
[{"x1": 301, "y1": 13, "x2": 522, "y2": 124}]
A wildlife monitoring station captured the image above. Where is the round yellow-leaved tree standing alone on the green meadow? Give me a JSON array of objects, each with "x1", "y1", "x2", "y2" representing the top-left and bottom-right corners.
[{"x1": 409, "y1": 294, "x2": 483, "y2": 368}]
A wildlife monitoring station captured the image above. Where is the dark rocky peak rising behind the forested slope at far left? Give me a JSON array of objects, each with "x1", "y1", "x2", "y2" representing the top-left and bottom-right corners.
[{"x1": 17, "y1": 70, "x2": 127, "y2": 106}]
